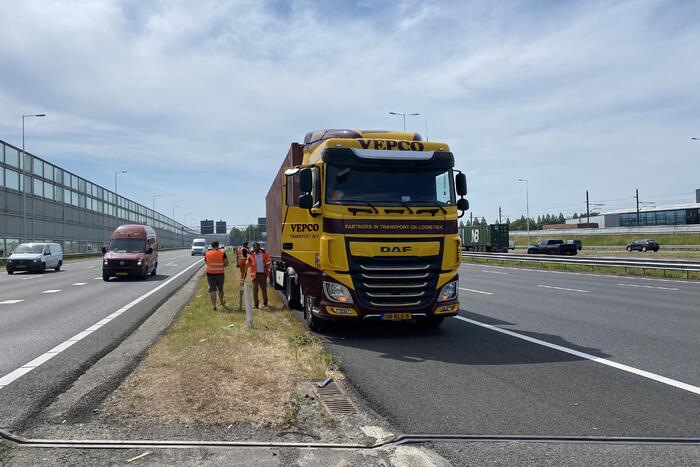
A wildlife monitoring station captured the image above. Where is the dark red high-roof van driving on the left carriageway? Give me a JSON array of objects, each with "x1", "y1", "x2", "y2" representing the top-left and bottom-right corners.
[{"x1": 102, "y1": 224, "x2": 158, "y2": 281}]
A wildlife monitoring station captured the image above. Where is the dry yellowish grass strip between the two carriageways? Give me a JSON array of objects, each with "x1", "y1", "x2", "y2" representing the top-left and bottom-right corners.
[{"x1": 105, "y1": 267, "x2": 342, "y2": 428}]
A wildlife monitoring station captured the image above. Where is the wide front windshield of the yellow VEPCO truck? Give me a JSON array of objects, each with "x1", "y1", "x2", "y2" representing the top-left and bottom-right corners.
[{"x1": 326, "y1": 165, "x2": 455, "y2": 205}]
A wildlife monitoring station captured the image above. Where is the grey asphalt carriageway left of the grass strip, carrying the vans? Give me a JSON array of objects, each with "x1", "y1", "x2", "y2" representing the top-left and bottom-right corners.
[{"x1": 0, "y1": 250, "x2": 202, "y2": 428}]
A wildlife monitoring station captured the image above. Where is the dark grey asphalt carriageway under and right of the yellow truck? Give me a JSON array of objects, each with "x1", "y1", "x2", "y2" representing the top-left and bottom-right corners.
[{"x1": 323, "y1": 264, "x2": 700, "y2": 463}]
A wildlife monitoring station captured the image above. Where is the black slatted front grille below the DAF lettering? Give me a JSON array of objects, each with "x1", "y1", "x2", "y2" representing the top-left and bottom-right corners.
[{"x1": 351, "y1": 257, "x2": 439, "y2": 310}]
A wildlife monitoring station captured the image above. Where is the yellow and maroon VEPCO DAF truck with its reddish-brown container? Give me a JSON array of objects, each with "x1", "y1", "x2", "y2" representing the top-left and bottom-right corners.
[{"x1": 266, "y1": 130, "x2": 469, "y2": 331}]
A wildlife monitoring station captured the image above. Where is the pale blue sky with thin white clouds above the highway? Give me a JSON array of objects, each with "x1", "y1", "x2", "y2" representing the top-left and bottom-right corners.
[{"x1": 0, "y1": 0, "x2": 700, "y2": 225}]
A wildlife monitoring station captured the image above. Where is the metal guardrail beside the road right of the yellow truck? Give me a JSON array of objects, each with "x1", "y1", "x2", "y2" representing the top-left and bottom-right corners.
[{"x1": 462, "y1": 252, "x2": 700, "y2": 279}]
